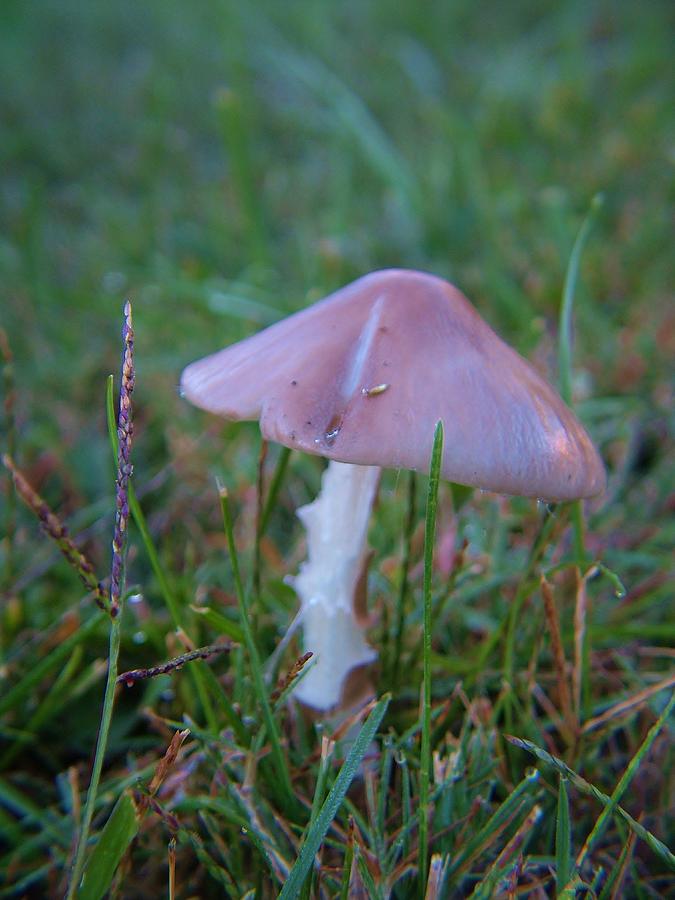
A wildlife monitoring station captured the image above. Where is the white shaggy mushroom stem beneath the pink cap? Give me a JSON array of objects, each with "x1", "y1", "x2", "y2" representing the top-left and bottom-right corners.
[{"x1": 288, "y1": 460, "x2": 380, "y2": 710}]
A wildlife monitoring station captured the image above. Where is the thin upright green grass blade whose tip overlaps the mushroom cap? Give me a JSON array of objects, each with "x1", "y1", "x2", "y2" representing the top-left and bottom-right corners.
[{"x1": 418, "y1": 421, "x2": 443, "y2": 896}]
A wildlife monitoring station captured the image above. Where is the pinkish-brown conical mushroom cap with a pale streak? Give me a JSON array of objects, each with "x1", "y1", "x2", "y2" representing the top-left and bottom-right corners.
[{"x1": 181, "y1": 269, "x2": 605, "y2": 501}]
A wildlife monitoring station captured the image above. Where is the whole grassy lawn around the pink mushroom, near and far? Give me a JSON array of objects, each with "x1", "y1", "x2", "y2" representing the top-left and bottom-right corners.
[{"x1": 0, "y1": 0, "x2": 675, "y2": 898}]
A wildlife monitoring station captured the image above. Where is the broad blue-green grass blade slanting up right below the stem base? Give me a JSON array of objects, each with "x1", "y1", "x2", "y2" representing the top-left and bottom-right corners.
[{"x1": 279, "y1": 695, "x2": 390, "y2": 900}]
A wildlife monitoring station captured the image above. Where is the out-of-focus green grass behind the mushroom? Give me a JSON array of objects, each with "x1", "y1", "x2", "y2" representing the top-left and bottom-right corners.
[{"x1": 0, "y1": 0, "x2": 675, "y2": 896}]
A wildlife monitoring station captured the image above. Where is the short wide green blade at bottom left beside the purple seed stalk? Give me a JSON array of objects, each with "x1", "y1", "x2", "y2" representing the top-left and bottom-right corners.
[{"x1": 77, "y1": 791, "x2": 139, "y2": 900}]
